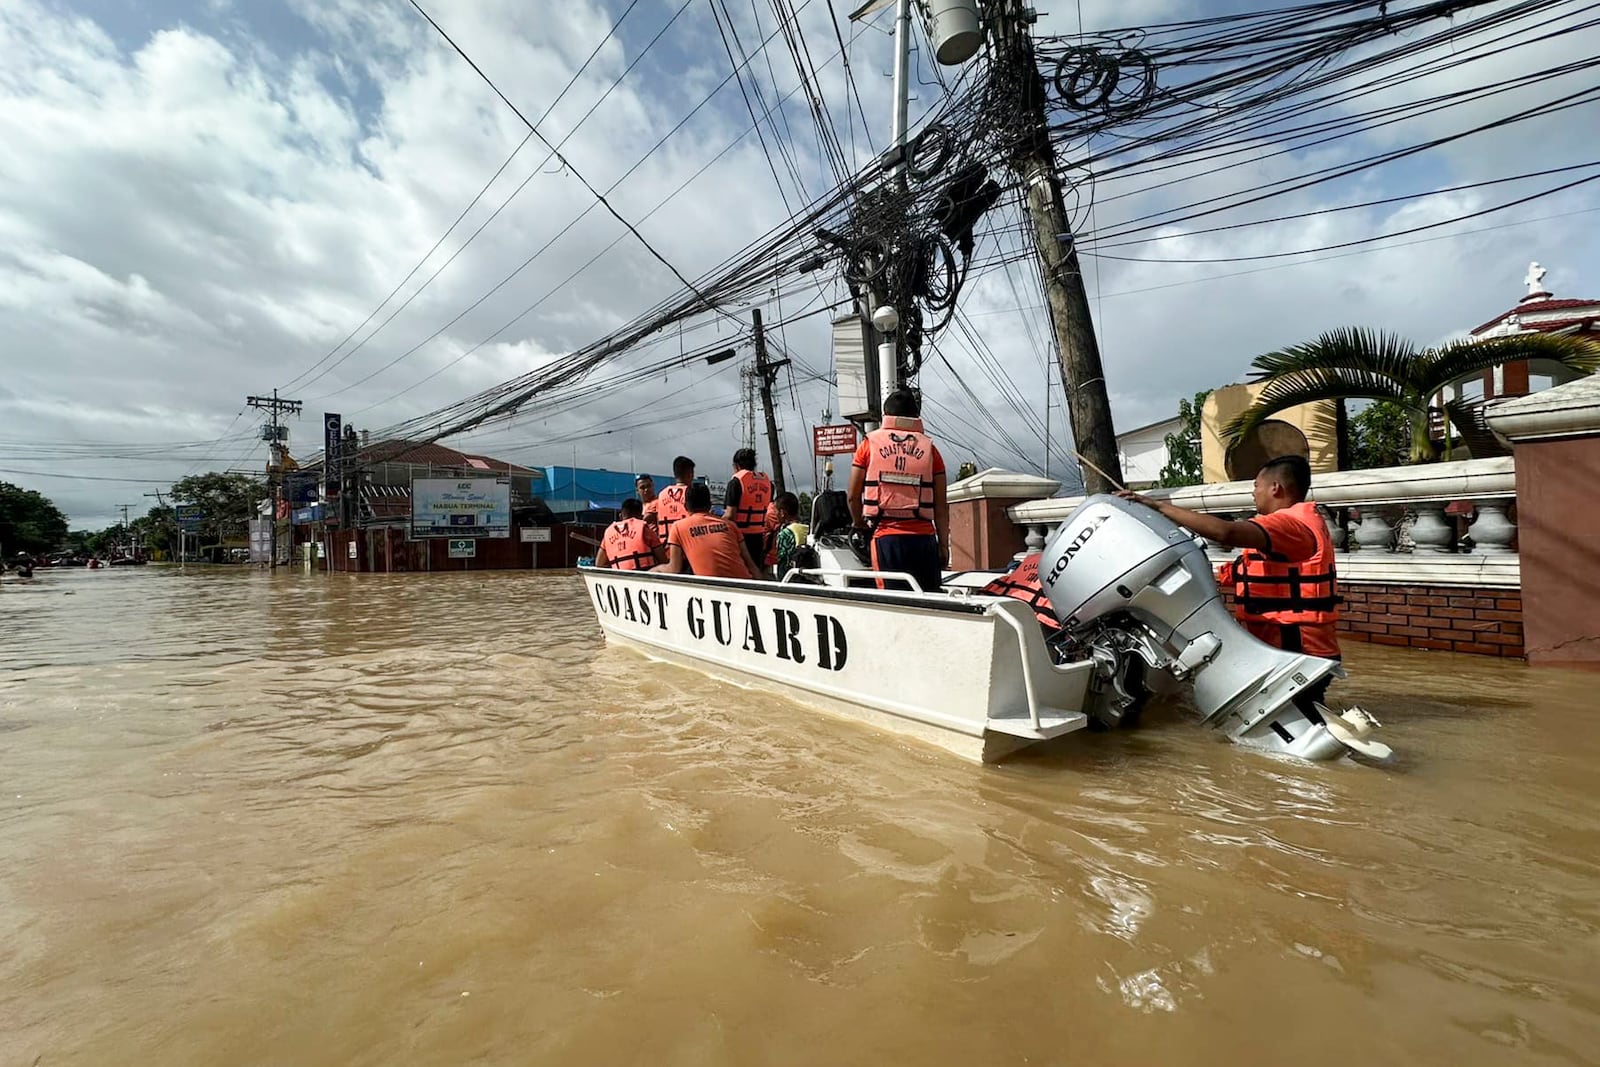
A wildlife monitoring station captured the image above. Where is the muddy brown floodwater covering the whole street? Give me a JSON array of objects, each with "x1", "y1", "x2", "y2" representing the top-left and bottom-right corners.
[{"x1": 0, "y1": 566, "x2": 1600, "y2": 1067}]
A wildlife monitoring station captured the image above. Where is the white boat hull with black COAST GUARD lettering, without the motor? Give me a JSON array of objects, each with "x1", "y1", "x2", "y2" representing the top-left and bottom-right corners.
[{"x1": 581, "y1": 568, "x2": 1093, "y2": 761}]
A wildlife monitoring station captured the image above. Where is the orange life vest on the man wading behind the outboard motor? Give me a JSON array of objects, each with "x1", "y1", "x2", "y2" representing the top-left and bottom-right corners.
[{"x1": 1229, "y1": 501, "x2": 1339, "y2": 656}]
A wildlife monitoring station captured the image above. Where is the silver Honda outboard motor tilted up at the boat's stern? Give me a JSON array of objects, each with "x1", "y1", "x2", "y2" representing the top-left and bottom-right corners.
[{"x1": 1038, "y1": 496, "x2": 1387, "y2": 760}]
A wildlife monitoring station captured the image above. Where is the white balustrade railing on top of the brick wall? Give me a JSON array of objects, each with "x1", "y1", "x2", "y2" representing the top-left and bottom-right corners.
[{"x1": 1006, "y1": 456, "x2": 1522, "y2": 587}]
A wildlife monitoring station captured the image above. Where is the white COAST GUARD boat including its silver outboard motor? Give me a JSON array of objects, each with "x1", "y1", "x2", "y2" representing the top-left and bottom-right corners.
[{"x1": 581, "y1": 496, "x2": 1389, "y2": 761}]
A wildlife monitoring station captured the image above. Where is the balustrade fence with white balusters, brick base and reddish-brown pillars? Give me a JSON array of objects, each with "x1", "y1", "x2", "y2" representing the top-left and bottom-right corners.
[{"x1": 950, "y1": 378, "x2": 1600, "y2": 669}]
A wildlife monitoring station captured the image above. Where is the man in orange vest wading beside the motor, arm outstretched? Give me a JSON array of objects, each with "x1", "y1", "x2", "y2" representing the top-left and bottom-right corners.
[{"x1": 1118, "y1": 456, "x2": 1339, "y2": 707}]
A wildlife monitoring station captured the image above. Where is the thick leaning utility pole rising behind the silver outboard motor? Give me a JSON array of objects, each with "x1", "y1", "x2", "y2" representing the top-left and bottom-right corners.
[{"x1": 994, "y1": 0, "x2": 1122, "y2": 493}]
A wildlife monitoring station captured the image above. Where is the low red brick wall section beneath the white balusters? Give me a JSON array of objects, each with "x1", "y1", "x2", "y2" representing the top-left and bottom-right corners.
[{"x1": 1339, "y1": 582, "x2": 1523, "y2": 656}]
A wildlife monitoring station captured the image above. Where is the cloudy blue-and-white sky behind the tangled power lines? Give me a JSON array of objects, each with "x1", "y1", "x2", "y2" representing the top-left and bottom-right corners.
[{"x1": 0, "y1": 0, "x2": 1600, "y2": 526}]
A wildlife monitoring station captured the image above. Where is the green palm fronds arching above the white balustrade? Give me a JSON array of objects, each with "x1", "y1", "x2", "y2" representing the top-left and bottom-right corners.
[{"x1": 1222, "y1": 326, "x2": 1600, "y2": 462}]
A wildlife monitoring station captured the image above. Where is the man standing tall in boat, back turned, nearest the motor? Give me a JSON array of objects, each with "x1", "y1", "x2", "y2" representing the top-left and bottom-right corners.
[{"x1": 850, "y1": 389, "x2": 950, "y2": 592}]
